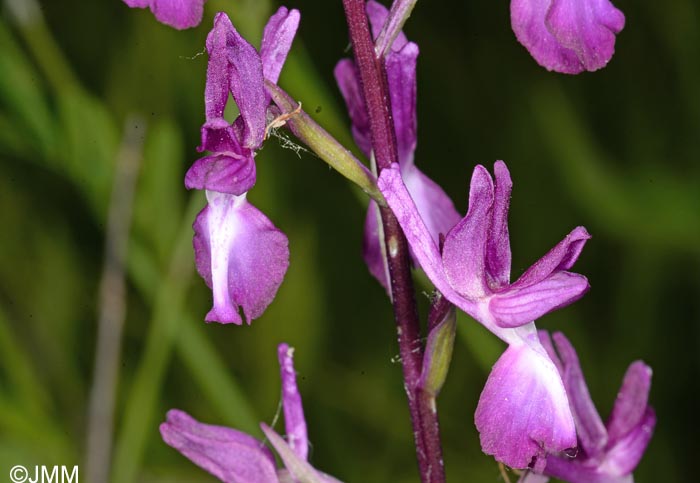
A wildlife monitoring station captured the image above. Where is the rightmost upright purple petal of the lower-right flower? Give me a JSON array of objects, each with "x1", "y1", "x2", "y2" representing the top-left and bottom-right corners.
[{"x1": 606, "y1": 361, "x2": 651, "y2": 444}]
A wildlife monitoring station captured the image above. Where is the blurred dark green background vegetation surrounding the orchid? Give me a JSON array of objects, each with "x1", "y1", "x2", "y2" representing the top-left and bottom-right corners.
[{"x1": 0, "y1": 0, "x2": 700, "y2": 483}]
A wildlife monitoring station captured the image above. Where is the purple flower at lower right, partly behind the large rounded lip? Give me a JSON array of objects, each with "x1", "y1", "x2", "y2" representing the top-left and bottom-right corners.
[{"x1": 520, "y1": 331, "x2": 656, "y2": 483}]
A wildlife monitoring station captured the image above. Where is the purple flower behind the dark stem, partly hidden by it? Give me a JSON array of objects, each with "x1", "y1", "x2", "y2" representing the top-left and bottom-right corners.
[{"x1": 334, "y1": 0, "x2": 460, "y2": 292}]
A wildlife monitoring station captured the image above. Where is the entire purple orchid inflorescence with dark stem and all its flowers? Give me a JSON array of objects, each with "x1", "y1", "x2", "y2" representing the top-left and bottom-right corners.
[{"x1": 124, "y1": 0, "x2": 656, "y2": 483}]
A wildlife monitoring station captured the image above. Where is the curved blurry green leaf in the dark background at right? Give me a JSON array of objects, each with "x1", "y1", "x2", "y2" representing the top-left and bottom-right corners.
[{"x1": 532, "y1": 83, "x2": 700, "y2": 250}]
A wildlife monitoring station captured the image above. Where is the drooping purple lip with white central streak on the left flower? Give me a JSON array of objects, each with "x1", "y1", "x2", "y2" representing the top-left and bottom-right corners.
[{"x1": 193, "y1": 191, "x2": 289, "y2": 324}]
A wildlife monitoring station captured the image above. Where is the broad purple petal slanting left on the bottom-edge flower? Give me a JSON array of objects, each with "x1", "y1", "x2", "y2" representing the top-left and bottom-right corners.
[{"x1": 160, "y1": 409, "x2": 278, "y2": 483}]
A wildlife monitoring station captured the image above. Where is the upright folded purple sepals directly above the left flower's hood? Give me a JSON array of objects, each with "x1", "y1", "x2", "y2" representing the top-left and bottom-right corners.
[{"x1": 205, "y1": 12, "x2": 267, "y2": 149}]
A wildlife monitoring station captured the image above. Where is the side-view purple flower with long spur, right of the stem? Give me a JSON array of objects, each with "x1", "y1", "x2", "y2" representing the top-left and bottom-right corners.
[{"x1": 378, "y1": 161, "x2": 590, "y2": 468}]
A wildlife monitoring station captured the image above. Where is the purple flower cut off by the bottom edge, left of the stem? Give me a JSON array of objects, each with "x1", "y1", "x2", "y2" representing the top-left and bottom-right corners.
[{"x1": 160, "y1": 344, "x2": 340, "y2": 483}]
